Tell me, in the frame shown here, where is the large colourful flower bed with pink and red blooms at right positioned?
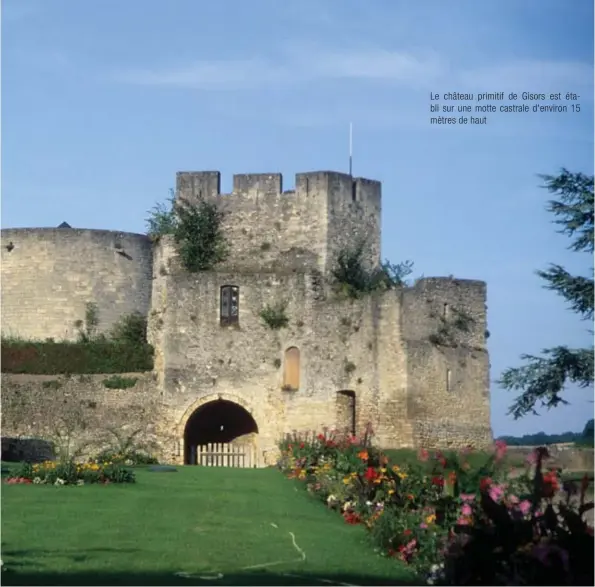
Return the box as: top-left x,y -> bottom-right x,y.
279,428 -> 594,585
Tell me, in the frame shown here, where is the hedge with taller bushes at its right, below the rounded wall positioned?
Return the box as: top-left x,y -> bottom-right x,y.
0,303 -> 153,375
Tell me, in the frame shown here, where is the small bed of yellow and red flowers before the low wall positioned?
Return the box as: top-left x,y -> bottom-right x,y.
6,461 -> 135,485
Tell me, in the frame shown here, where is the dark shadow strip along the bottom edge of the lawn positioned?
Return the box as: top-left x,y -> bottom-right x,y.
2,569 -> 423,586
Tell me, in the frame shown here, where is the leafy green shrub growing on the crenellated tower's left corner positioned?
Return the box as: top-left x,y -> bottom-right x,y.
147,191 -> 229,273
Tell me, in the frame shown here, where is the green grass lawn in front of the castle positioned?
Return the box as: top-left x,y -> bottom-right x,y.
2,467 -> 414,585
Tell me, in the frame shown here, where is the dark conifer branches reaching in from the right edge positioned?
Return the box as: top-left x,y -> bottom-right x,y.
498,169 -> 594,420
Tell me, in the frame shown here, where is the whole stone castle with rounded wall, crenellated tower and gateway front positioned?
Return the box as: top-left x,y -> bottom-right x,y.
1,172 -> 491,465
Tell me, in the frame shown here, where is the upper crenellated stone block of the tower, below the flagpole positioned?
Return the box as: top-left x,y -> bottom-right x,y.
176,171 -> 382,272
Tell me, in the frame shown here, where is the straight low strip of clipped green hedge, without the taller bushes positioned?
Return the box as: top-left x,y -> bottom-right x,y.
1,340 -> 153,375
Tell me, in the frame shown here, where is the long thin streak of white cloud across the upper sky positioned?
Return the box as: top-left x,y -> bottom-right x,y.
112,44 -> 593,107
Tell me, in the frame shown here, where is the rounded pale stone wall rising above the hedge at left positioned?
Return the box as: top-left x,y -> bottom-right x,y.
0,228 -> 153,340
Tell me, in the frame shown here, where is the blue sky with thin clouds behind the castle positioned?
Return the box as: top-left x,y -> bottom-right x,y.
2,0 -> 593,434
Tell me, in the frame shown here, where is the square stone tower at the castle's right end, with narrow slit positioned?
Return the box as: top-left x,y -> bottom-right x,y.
402,278 -> 492,448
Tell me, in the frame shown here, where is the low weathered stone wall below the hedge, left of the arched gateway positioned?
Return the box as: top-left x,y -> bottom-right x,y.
2,373 -> 177,460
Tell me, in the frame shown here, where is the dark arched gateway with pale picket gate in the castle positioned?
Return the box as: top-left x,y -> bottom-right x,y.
183,395 -> 258,467
